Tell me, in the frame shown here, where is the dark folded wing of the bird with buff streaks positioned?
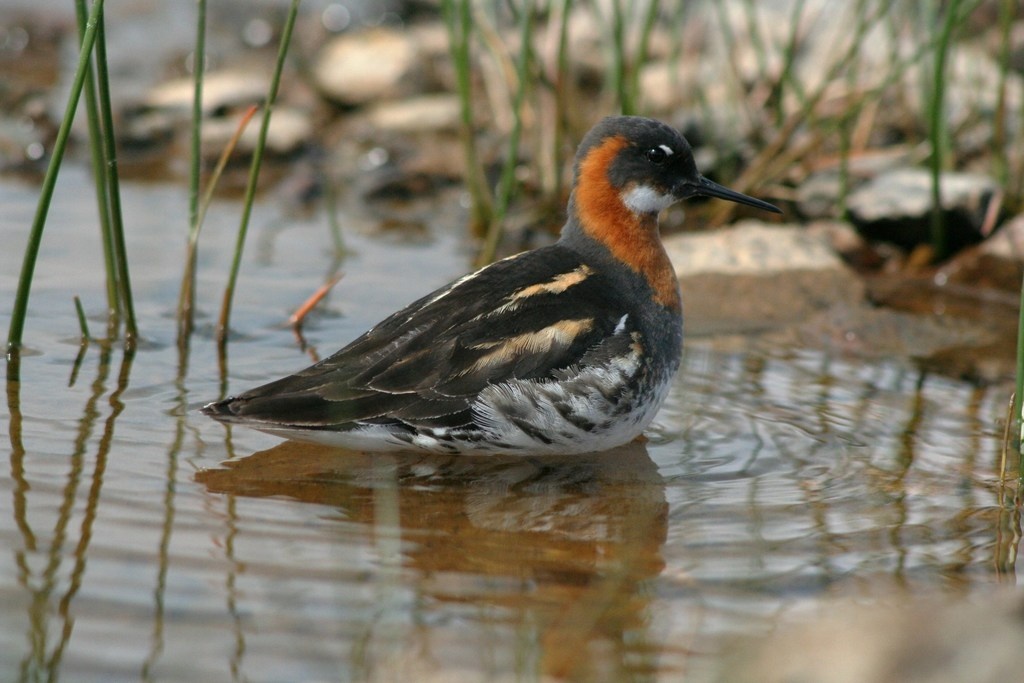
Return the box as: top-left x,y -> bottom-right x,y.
208,245 -> 628,429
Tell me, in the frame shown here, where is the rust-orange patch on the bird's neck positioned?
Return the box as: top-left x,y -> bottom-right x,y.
570,135 -> 681,310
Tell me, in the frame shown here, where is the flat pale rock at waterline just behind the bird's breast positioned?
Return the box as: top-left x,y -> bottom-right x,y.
665,220 -> 864,334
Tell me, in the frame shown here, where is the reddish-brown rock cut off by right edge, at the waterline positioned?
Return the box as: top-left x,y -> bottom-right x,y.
937,214 -> 1024,293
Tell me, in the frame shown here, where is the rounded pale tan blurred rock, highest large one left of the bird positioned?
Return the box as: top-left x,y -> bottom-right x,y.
312,29 -> 421,106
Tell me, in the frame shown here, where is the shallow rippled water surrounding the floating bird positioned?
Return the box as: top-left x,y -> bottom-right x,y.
0,166 -> 1020,681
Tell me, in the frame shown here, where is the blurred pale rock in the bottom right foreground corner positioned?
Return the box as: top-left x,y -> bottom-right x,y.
717,593 -> 1024,683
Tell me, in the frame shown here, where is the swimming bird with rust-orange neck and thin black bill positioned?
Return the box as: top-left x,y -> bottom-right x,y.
202,116 -> 781,456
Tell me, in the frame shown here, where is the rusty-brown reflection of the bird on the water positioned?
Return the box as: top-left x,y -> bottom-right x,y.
197,441 -> 668,679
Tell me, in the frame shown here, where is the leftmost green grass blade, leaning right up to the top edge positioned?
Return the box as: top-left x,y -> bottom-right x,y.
7,0 -> 103,362
